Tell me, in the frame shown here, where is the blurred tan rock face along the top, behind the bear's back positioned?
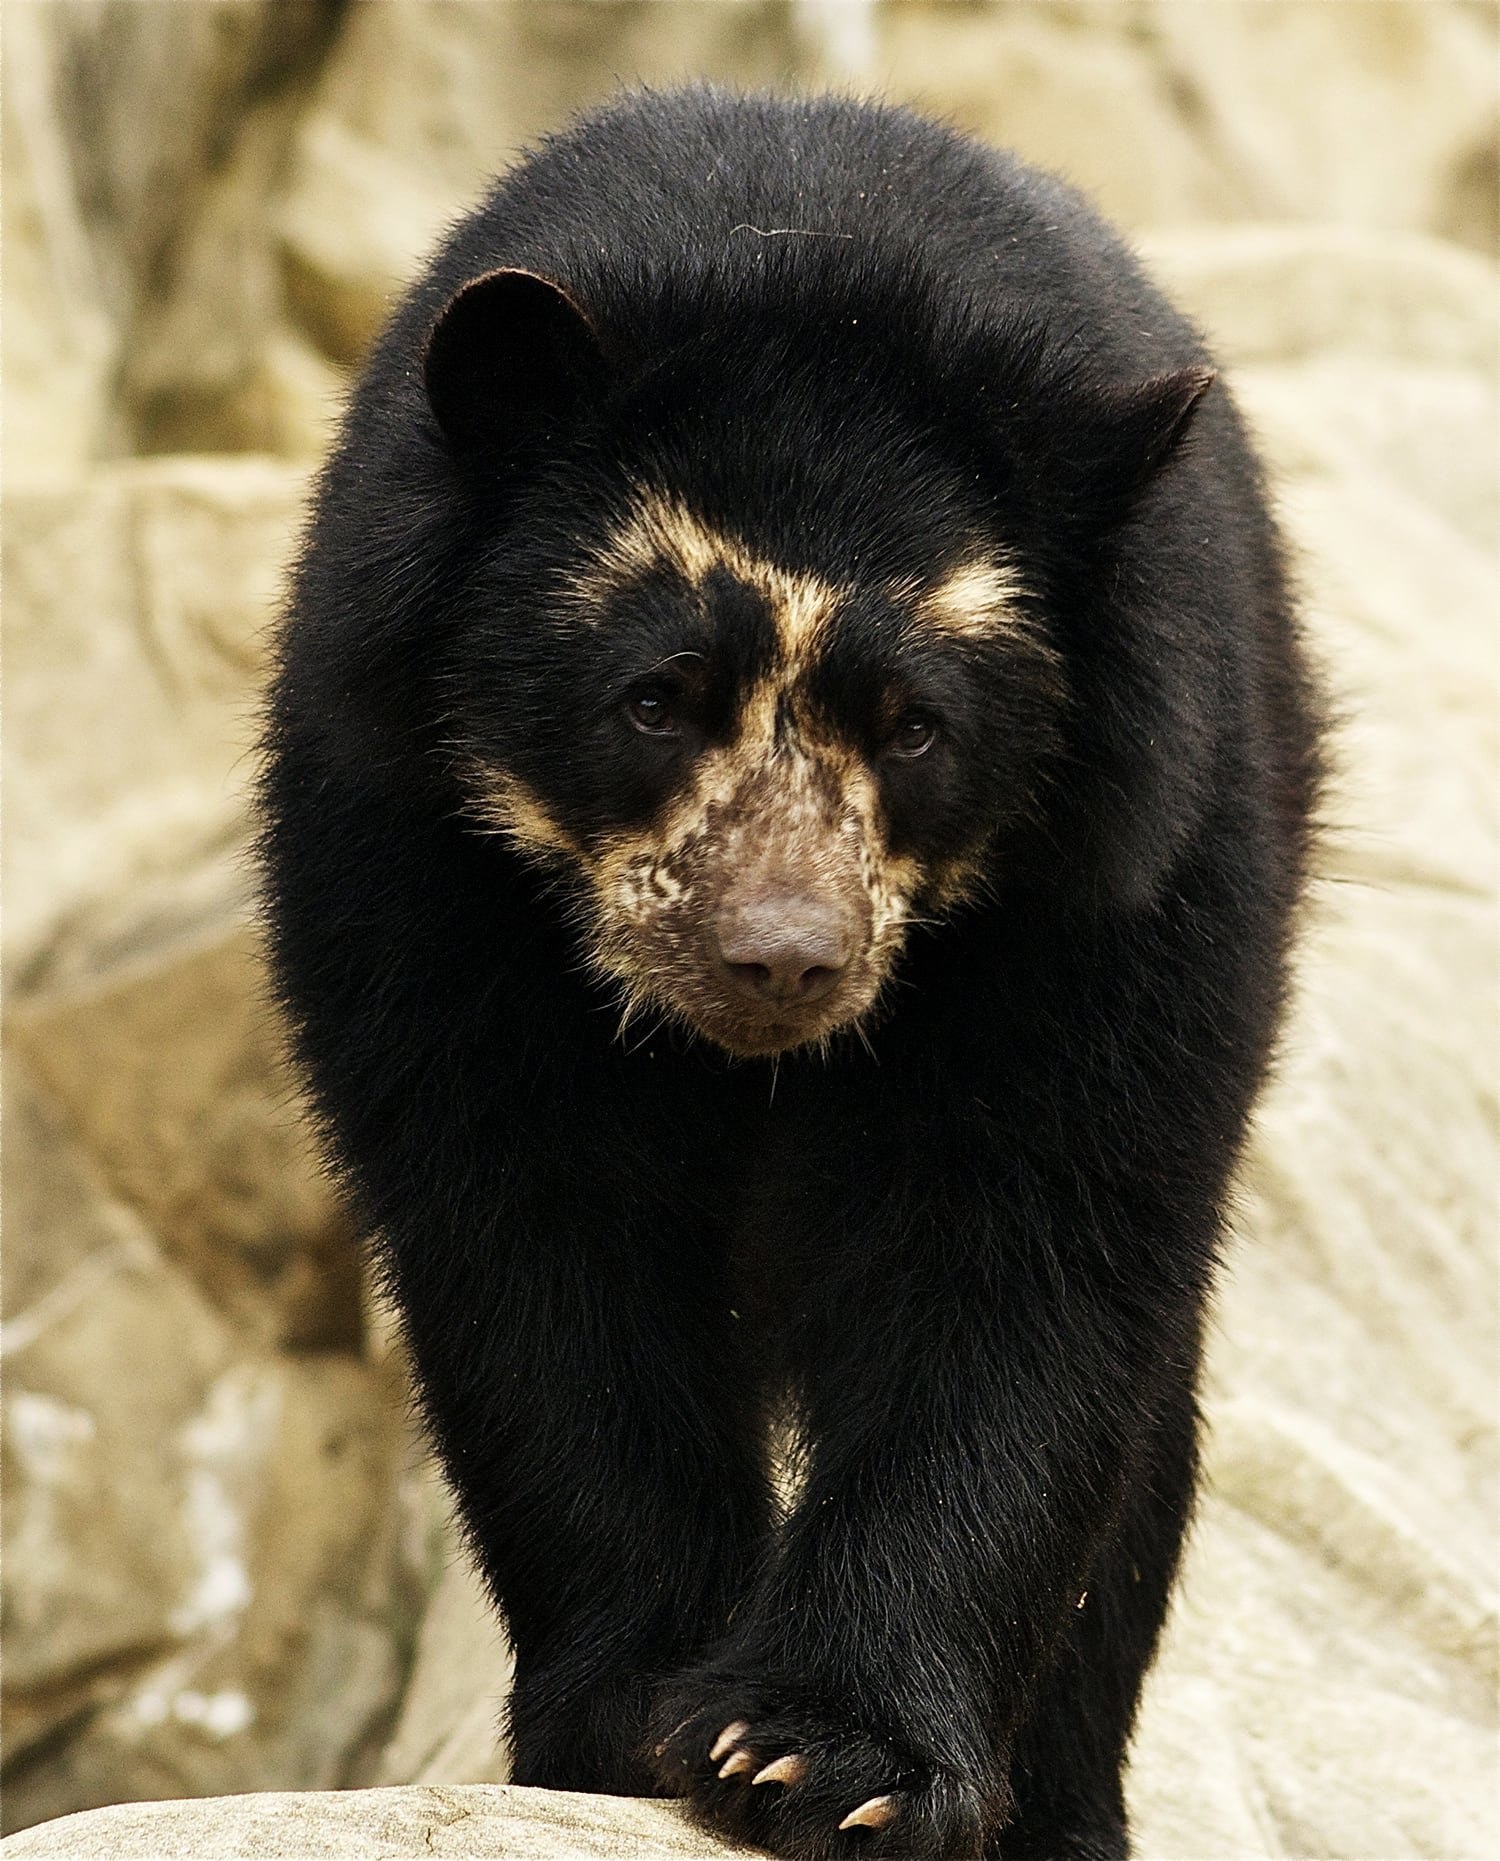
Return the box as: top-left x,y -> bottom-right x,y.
4,0 -> 1500,469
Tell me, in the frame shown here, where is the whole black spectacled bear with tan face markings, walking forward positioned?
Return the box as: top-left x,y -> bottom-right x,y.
261,89 -> 1318,1861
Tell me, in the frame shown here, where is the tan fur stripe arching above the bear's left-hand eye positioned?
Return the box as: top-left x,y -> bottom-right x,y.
577,491 -> 839,666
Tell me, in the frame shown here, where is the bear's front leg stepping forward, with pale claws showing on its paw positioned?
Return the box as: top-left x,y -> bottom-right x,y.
657,1146 -> 1197,1861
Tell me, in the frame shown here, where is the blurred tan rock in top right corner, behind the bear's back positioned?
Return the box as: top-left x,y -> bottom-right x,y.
874,0 -> 1500,253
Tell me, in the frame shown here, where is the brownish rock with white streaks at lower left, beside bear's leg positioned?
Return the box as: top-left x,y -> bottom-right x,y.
0,1053 -> 416,1828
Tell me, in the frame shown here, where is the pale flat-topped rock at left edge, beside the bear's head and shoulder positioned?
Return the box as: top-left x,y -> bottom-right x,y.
4,458 -> 305,990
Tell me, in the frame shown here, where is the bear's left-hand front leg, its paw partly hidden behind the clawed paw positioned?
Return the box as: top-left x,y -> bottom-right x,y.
372,1083 -> 770,1794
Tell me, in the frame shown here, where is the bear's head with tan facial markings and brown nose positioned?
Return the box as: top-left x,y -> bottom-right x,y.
424,270 -> 1206,1055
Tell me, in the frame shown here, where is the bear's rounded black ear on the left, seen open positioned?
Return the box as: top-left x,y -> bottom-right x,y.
422,270 -> 605,456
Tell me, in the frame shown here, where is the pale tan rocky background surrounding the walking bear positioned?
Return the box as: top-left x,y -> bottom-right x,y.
0,0 -> 1500,1855
